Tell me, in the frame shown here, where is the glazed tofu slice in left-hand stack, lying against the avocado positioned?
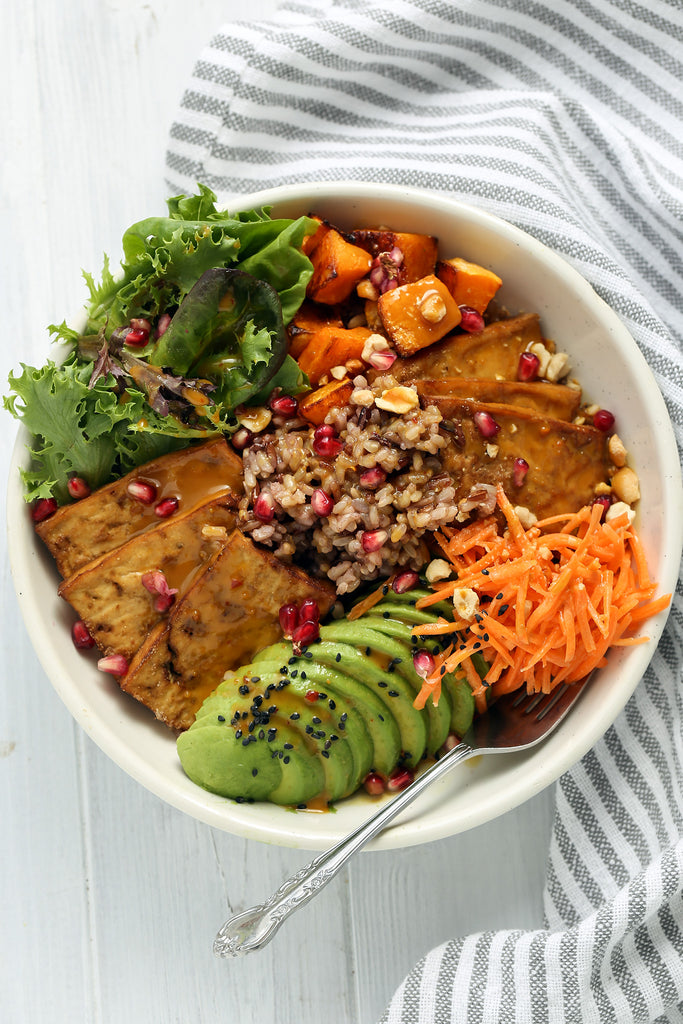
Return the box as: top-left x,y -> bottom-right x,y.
119,530 -> 335,729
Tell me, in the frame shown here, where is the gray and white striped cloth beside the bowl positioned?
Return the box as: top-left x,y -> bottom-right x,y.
167,0 -> 683,1024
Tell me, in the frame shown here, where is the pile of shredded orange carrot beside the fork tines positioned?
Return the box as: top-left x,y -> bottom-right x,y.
415,487 -> 671,711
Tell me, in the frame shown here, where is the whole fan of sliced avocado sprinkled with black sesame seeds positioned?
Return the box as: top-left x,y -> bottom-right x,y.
178,589 -> 485,807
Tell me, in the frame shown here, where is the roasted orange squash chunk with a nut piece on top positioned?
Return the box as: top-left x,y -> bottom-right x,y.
377,274 -> 461,356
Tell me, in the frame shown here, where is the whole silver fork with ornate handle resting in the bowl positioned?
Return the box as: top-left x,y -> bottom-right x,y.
213,683 -> 585,957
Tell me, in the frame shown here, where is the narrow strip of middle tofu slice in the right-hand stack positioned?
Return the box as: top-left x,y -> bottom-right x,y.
415,377 -> 581,420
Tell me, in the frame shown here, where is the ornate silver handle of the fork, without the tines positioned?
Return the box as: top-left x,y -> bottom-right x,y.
213,742 -> 474,957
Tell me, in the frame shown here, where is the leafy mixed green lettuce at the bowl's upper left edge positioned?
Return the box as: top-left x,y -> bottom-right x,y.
4,185 -> 317,504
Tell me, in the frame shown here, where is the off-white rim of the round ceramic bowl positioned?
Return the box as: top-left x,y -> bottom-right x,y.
7,181 -> 683,850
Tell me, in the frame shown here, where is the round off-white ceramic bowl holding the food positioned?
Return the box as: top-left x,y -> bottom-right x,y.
8,182 -> 683,850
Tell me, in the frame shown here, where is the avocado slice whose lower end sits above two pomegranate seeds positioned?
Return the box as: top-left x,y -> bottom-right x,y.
255,643 -> 401,777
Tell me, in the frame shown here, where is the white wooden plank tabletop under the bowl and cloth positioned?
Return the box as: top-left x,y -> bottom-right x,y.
0,0 -> 553,1024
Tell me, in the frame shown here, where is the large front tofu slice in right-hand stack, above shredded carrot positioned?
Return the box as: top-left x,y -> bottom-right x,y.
423,397 -> 610,518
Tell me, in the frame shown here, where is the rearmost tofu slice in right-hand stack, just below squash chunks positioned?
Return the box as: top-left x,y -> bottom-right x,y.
391,313 -> 543,381
